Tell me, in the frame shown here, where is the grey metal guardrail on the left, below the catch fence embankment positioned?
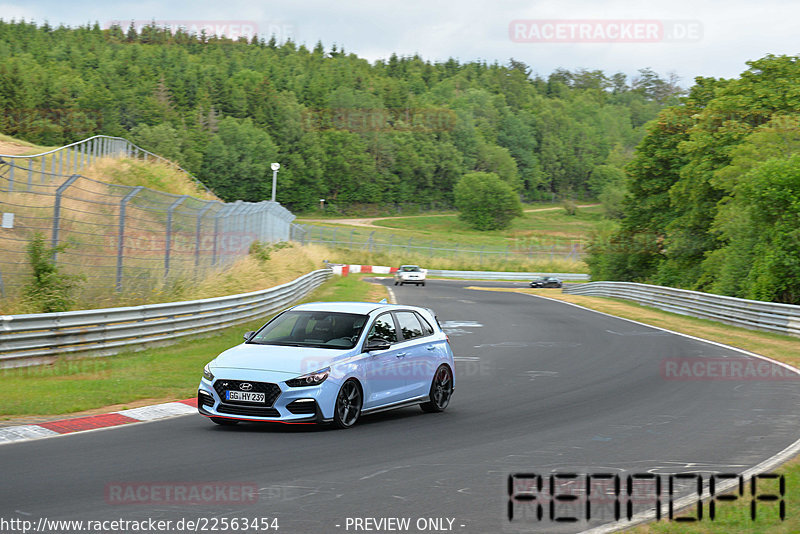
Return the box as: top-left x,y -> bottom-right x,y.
0,269 -> 331,368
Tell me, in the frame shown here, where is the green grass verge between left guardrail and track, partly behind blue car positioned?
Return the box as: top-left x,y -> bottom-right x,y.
0,276 -> 385,419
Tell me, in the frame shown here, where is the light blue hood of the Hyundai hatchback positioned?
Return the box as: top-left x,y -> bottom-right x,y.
210,343 -> 354,376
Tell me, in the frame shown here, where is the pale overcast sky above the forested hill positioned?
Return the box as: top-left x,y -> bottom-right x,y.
0,0 -> 800,86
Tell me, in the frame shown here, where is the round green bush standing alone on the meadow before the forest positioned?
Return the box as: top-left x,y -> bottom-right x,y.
453,172 -> 522,230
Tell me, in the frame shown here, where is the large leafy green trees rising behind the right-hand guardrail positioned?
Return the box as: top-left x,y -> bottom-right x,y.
589,55 -> 800,304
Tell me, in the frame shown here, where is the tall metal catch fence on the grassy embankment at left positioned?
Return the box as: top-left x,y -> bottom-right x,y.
0,136 -> 294,297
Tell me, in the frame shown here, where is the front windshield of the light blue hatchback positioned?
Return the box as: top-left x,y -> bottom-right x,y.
247,311 -> 368,349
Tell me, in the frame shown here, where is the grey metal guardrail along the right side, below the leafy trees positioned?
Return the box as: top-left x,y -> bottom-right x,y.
563,282 -> 800,336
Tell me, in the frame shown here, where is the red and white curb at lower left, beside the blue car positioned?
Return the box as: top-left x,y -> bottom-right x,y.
0,398 -> 197,445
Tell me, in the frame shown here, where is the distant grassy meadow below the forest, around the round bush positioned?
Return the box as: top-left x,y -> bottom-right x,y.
298,205 -> 612,273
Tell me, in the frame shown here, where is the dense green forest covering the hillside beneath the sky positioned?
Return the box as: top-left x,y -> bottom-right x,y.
0,21 -> 682,213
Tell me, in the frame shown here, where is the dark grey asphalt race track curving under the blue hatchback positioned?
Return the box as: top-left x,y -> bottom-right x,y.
0,280 -> 800,534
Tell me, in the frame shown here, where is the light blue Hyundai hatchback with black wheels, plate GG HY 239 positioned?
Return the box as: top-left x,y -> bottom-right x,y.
197,302 -> 455,428
